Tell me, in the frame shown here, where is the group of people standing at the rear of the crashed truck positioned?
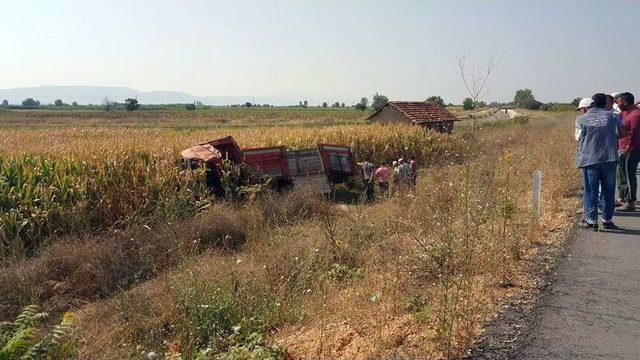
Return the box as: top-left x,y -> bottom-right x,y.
358,158 -> 418,202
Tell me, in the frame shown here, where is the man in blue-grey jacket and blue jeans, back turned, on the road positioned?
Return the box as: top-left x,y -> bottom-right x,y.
576,93 -> 618,230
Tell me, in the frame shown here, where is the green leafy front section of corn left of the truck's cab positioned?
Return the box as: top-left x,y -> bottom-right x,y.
0,151 -> 205,260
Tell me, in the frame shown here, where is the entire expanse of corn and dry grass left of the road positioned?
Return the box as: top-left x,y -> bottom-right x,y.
0,108 -> 579,359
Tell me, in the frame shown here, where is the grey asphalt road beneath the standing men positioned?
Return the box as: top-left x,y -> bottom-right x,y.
512,173 -> 640,359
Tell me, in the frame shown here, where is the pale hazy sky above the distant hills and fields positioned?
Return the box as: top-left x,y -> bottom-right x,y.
0,0 -> 640,103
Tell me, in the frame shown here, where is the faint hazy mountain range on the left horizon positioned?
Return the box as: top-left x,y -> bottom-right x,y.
0,86 -> 278,105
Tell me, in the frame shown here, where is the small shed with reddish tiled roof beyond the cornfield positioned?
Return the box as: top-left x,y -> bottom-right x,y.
369,101 -> 458,133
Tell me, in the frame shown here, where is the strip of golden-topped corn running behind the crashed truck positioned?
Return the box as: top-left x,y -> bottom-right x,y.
0,125 -> 467,164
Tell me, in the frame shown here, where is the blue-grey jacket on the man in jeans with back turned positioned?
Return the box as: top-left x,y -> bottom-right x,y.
576,108 -> 618,168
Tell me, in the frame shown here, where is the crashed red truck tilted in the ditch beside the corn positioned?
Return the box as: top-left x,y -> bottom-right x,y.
180,136 -> 357,194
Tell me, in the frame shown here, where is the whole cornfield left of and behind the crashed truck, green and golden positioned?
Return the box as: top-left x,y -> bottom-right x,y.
0,125 -> 465,260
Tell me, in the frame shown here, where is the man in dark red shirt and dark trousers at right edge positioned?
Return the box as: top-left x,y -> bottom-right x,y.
617,92 -> 640,211
